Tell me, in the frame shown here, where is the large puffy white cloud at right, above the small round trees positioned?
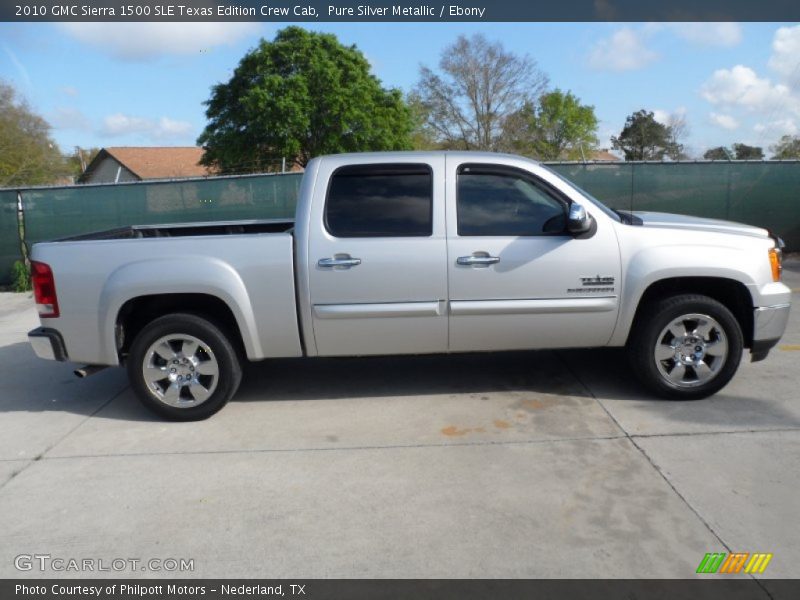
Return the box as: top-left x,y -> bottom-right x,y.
700,65 -> 800,112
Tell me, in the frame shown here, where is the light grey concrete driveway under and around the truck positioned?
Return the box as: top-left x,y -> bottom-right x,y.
0,262 -> 800,597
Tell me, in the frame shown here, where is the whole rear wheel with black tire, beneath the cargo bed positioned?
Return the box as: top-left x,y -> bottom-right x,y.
127,313 -> 242,421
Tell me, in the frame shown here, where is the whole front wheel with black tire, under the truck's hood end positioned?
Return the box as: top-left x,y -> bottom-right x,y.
628,294 -> 744,400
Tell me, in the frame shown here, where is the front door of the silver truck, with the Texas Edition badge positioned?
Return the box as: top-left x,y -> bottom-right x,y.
447,154 -> 621,351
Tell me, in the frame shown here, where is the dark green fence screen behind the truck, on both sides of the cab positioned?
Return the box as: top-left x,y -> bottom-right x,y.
0,161 -> 800,284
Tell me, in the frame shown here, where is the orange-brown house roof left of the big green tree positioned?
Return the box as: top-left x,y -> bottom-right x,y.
84,146 -> 213,179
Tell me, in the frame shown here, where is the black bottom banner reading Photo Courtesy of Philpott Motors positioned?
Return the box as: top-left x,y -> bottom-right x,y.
0,576 -> 800,600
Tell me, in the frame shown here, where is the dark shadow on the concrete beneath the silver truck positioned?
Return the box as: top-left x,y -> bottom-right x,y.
0,343 -> 800,427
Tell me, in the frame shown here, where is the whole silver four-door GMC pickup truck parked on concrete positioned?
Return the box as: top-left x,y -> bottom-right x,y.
29,152 -> 791,420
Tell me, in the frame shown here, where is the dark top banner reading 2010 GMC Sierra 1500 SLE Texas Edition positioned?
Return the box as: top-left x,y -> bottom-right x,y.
0,0 -> 800,22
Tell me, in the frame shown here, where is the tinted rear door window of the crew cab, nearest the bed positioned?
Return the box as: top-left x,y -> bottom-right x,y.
325,164 -> 433,237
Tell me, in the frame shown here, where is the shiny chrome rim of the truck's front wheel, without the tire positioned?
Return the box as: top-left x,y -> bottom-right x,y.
654,313 -> 728,388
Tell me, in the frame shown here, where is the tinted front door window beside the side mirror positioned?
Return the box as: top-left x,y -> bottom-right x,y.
456,165 -> 567,237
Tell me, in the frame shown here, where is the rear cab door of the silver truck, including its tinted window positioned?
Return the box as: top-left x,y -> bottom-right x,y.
308,155 -> 447,356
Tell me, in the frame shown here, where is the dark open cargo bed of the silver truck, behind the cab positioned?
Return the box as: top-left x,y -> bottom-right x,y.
55,219 -> 294,242
